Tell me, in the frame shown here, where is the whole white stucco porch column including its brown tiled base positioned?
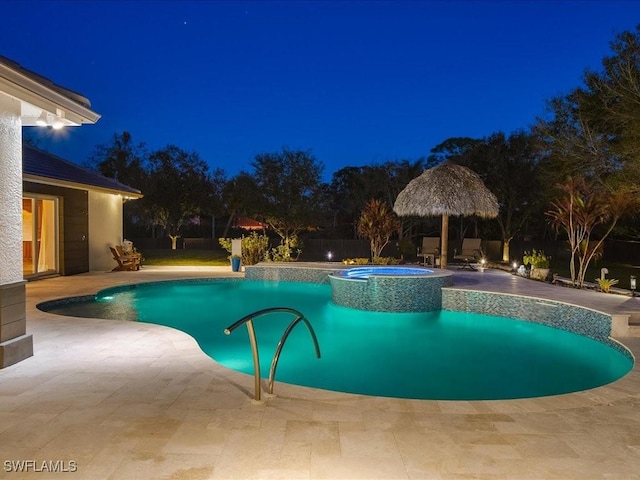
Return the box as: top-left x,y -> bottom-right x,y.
0,92 -> 33,368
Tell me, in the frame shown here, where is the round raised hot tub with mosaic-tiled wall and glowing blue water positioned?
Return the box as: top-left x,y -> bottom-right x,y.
329,266 -> 453,312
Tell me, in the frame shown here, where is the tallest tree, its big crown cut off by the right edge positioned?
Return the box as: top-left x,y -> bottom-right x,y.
535,26 -> 640,195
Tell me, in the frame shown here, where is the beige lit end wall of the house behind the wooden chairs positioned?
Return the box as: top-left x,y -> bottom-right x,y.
89,191 -> 123,272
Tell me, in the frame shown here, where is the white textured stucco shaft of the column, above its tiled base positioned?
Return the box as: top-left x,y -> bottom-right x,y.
0,93 -> 23,285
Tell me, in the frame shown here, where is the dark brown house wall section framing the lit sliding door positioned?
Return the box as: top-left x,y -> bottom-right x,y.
20,182 -> 89,275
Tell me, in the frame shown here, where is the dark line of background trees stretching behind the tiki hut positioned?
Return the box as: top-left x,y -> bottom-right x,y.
80,26 -> 640,260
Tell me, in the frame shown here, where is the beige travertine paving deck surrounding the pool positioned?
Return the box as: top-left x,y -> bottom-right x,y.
0,267 -> 640,480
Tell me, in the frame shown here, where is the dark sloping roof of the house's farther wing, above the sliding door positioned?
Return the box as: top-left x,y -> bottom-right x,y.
22,145 -> 142,198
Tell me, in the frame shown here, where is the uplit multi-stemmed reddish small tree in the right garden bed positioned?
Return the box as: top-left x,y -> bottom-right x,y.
546,177 -> 638,287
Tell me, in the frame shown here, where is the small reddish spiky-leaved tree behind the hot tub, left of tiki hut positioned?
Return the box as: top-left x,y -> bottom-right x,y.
358,198 -> 400,262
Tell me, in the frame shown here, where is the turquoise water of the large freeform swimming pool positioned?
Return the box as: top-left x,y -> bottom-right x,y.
42,279 -> 632,400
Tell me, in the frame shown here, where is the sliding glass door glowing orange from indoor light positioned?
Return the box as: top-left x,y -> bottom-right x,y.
22,196 -> 58,276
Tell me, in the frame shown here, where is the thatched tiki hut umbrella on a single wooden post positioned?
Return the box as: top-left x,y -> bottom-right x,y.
393,162 -> 498,268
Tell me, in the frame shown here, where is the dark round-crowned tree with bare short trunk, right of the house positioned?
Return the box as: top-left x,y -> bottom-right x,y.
143,145 -> 213,250
